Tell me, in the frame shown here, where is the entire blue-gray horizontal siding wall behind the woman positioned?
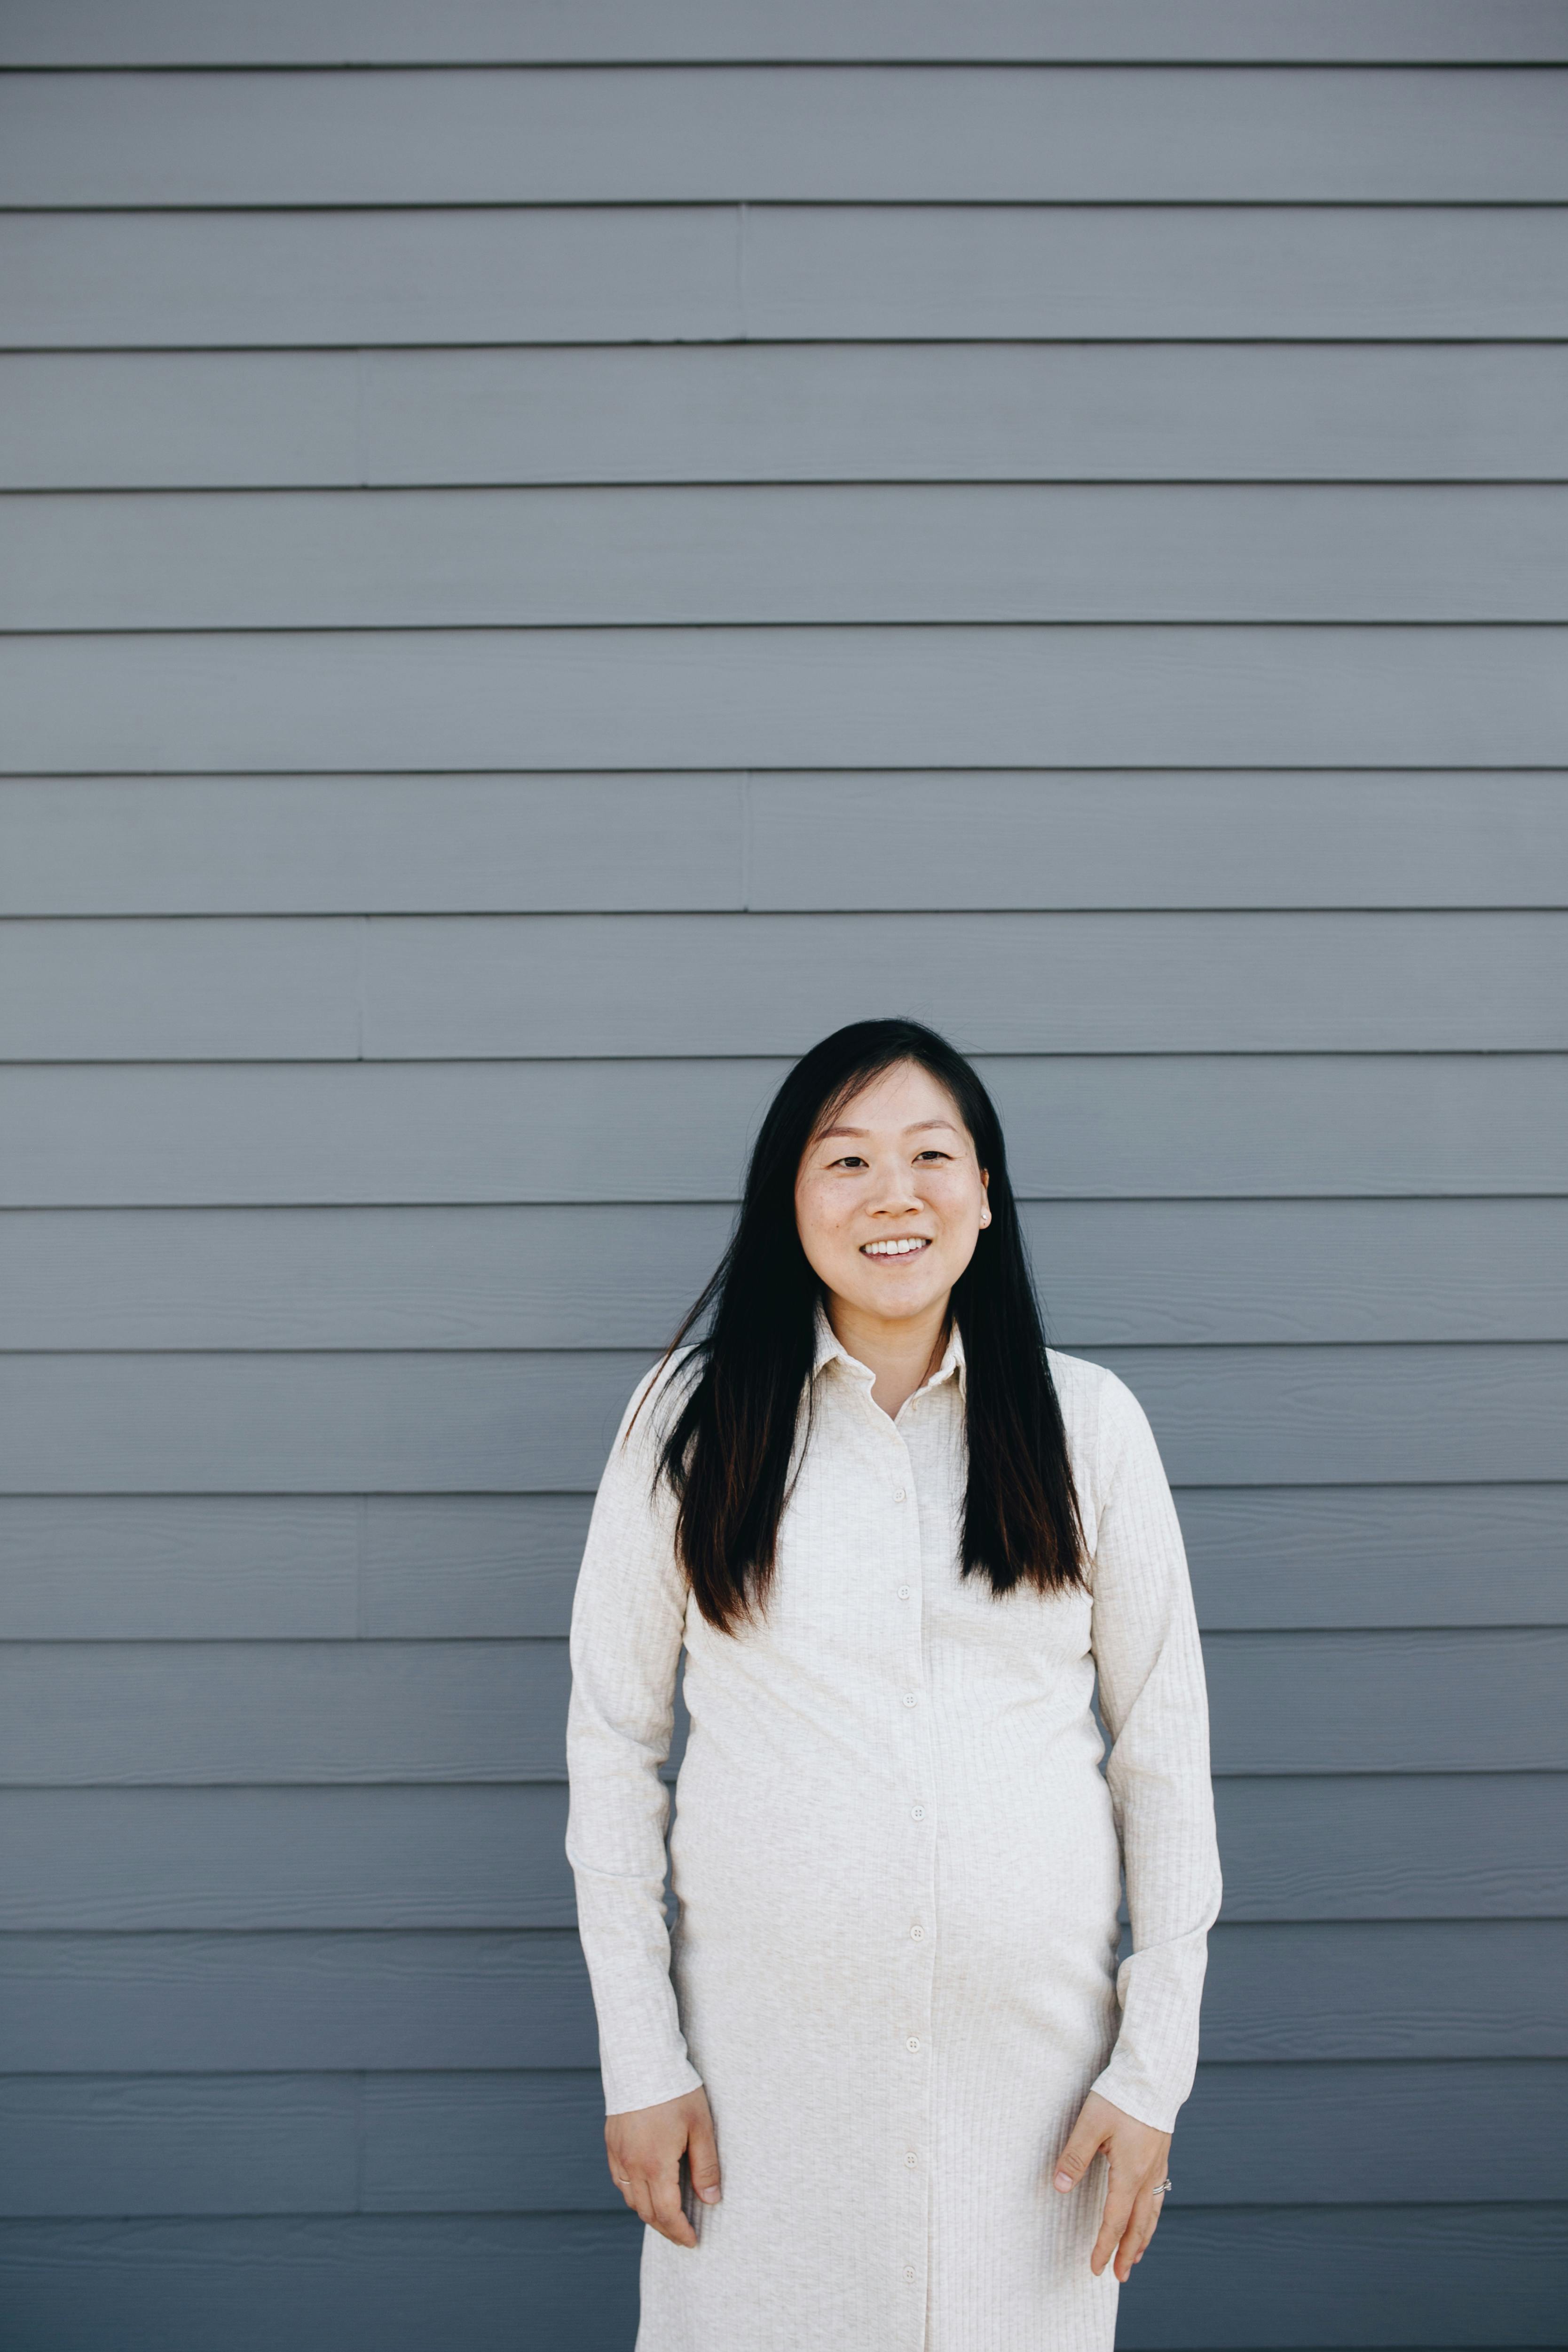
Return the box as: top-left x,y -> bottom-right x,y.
0,0 -> 1568,2352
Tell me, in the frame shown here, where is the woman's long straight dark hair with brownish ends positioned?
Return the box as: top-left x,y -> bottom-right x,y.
656,1021 -> 1086,1632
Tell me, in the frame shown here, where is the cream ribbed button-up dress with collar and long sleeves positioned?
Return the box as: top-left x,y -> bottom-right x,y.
567,1310 -> 1220,2352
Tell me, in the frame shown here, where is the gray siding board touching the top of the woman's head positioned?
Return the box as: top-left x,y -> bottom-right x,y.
0,917 -> 1568,1061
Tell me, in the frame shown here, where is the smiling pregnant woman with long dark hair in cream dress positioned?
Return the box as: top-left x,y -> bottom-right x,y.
567,1021 -> 1220,2352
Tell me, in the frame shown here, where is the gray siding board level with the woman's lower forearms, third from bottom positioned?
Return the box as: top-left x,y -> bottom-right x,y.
0,1919 -> 1568,2069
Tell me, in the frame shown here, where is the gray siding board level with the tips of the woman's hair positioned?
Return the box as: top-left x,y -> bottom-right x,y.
0,1482 -> 1568,1642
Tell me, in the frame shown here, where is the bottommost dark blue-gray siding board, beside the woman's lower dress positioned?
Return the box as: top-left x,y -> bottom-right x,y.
0,2204 -> 1568,2352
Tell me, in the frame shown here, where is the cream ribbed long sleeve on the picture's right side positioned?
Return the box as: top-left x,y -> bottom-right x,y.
1093,1373 -> 1220,2131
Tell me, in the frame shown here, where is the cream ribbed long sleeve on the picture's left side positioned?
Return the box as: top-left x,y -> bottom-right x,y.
567,1381 -> 701,2115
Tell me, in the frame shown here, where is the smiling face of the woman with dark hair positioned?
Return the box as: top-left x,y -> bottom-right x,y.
795,1061 -> 990,1322
